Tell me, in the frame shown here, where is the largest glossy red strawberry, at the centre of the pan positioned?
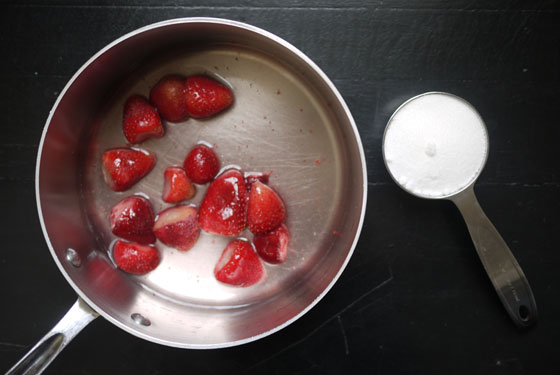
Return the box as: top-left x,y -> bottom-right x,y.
198,170 -> 247,236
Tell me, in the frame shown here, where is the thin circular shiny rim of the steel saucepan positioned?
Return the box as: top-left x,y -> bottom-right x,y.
35,17 -> 368,349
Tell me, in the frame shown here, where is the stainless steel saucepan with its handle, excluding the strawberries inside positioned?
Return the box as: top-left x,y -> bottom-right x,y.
9,18 -> 367,374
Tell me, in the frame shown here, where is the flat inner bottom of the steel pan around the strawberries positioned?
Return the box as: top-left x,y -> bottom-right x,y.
83,47 -> 343,308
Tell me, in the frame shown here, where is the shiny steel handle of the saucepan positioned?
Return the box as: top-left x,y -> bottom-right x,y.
6,298 -> 99,375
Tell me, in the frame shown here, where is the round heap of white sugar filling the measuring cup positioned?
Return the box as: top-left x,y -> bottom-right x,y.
383,93 -> 488,198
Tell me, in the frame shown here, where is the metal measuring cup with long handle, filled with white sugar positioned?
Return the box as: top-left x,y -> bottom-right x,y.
383,92 -> 537,327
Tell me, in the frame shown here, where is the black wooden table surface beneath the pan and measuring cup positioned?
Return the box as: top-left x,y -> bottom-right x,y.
0,0 -> 560,374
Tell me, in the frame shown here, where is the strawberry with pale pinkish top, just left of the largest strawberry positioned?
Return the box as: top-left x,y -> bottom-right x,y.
154,205 -> 200,251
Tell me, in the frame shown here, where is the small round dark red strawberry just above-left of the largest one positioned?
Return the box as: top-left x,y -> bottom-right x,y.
183,145 -> 220,184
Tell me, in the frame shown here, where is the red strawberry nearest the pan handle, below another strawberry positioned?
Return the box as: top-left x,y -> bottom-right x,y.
113,240 -> 160,275
